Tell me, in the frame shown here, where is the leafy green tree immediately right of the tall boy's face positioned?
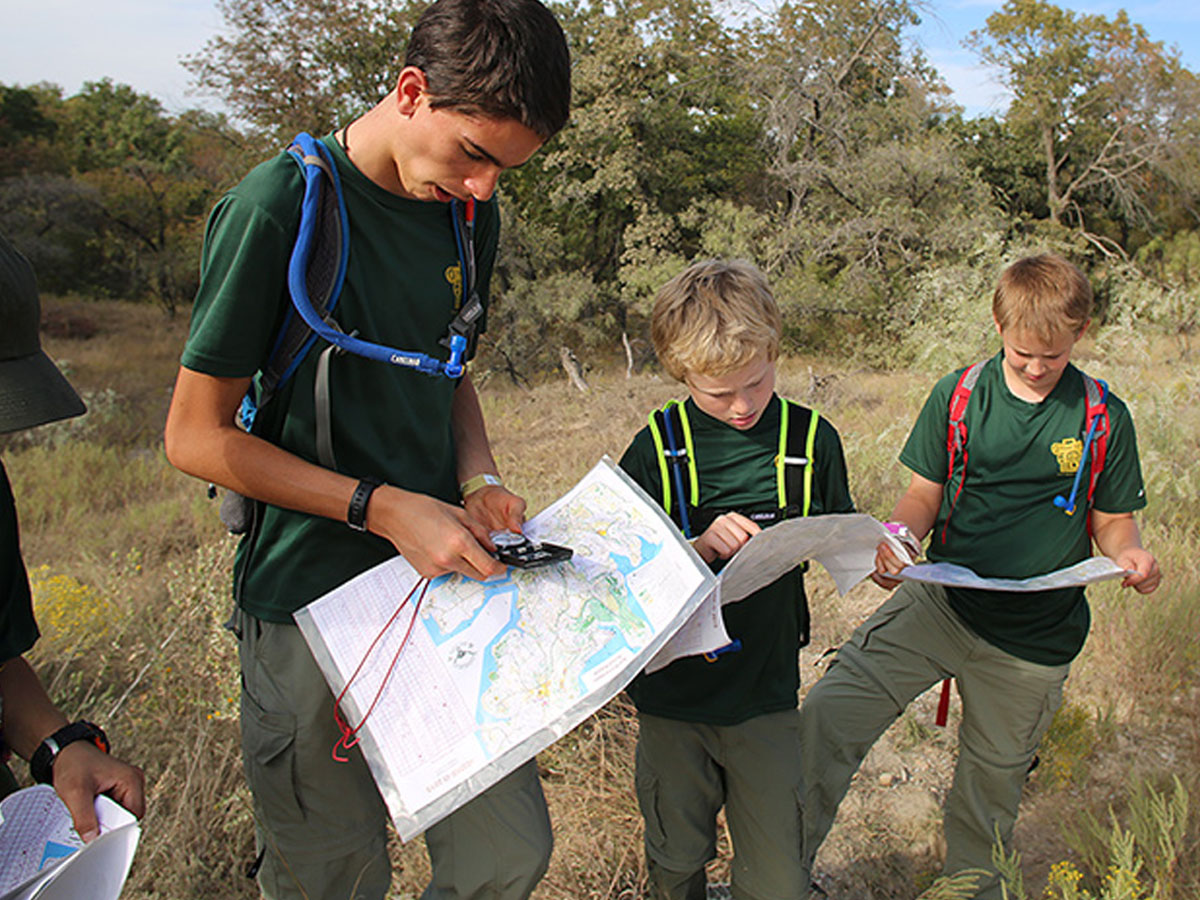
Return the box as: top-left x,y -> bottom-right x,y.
487,0 -> 766,365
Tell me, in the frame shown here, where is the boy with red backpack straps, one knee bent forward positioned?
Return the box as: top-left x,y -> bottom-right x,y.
800,254 -> 1160,900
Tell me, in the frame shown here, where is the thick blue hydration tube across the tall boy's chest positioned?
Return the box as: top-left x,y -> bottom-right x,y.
288,140 -> 467,378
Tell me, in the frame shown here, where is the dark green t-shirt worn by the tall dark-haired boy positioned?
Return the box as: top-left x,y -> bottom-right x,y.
182,137 -> 499,622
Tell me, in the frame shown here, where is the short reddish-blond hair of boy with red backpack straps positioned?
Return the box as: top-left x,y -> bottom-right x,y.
991,253 -> 1092,342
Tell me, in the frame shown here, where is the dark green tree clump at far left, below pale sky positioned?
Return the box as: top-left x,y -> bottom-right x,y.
0,79 -> 244,311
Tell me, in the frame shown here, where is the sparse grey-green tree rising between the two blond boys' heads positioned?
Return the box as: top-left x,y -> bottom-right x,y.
729,0 -> 997,349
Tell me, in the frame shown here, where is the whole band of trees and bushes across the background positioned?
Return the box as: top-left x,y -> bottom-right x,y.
0,0 -> 1200,367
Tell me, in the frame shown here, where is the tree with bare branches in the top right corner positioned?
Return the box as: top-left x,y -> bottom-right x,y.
970,0 -> 1196,252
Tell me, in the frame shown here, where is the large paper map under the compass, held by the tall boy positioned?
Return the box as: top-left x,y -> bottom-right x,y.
295,460 -> 715,840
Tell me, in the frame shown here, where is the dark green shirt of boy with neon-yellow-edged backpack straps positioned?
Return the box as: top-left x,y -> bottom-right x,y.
620,396 -> 854,725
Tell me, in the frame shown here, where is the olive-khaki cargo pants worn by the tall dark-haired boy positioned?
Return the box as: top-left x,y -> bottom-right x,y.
229,611 -> 552,900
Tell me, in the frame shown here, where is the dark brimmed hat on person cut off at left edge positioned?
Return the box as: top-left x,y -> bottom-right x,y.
0,234 -> 88,432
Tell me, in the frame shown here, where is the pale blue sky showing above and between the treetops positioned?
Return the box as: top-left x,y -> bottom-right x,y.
0,0 -> 1200,115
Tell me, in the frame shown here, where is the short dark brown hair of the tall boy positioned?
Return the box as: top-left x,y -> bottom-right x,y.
404,0 -> 571,139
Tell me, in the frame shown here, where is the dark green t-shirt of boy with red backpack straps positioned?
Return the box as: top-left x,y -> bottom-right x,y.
900,354 -> 1146,666
